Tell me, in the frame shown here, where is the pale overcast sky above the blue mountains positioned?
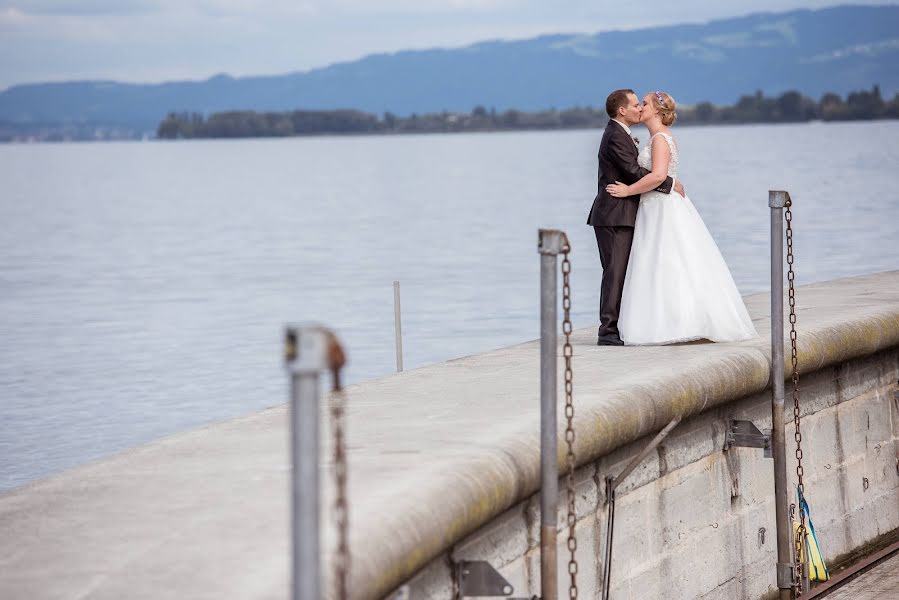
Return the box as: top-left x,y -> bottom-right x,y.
0,0 -> 899,89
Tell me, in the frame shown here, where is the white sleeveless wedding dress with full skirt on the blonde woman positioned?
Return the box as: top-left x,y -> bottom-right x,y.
618,133 -> 757,346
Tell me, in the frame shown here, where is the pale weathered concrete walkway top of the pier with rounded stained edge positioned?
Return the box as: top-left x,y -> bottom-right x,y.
0,271 -> 899,600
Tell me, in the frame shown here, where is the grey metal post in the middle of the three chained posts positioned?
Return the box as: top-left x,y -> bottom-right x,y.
538,229 -> 566,600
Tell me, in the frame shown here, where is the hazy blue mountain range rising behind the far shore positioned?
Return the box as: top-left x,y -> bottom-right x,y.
0,6 -> 899,131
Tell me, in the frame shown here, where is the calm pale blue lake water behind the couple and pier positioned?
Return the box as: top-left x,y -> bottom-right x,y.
0,121 -> 899,490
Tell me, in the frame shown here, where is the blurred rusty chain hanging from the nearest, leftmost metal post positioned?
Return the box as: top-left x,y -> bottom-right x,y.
330,339 -> 350,600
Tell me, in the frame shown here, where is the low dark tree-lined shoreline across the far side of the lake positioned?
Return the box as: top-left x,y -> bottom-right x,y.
0,85 -> 899,143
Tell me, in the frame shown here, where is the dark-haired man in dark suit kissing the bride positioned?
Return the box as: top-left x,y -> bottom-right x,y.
587,89 -> 683,346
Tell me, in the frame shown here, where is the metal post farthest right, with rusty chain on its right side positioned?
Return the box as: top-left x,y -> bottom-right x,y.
768,191 -> 793,600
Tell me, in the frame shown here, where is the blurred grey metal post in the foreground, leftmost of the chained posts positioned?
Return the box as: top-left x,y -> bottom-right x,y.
285,326 -> 328,600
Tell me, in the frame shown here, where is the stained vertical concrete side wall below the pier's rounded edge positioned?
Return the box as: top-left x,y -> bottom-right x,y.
394,348 -> 899,600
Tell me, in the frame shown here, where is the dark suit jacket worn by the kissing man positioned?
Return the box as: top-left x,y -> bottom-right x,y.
587,120 -> 674,227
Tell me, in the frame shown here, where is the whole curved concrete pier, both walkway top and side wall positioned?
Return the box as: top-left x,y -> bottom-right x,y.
0,271 -> 899,600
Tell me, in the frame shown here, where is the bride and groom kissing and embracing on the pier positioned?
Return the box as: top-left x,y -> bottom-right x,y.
587,89 -> 757,346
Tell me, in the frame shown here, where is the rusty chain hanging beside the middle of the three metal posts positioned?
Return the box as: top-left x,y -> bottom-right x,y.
562,244 -> 578,600
